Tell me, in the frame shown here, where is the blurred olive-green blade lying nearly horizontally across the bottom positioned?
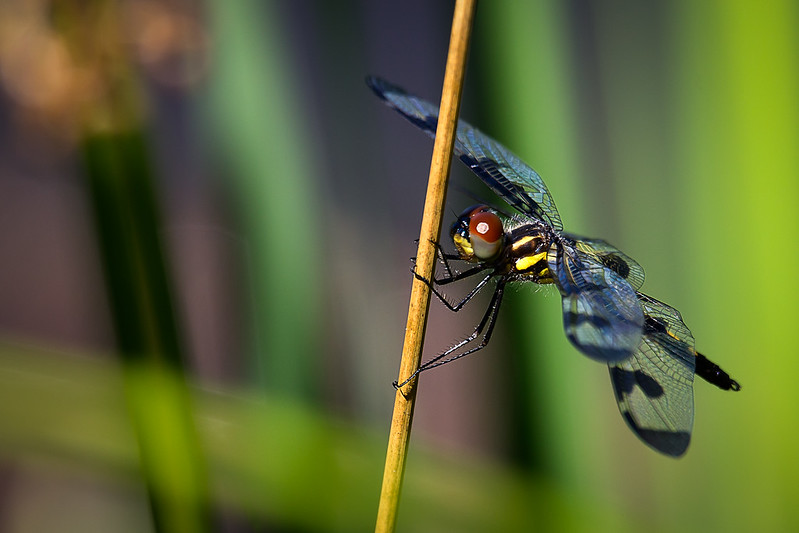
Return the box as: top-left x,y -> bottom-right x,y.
0,345 -> 640,533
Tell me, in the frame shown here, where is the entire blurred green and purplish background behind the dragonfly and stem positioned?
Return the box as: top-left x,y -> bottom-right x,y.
0,0 -> 799,532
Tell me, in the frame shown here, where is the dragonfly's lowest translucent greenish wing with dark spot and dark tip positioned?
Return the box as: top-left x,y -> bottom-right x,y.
608,293 -> 696,457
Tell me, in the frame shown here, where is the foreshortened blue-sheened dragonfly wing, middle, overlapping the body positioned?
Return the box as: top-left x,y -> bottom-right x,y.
547,239 -> 644,363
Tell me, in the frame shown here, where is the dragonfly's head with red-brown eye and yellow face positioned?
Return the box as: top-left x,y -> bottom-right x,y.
450,205 -> 505,263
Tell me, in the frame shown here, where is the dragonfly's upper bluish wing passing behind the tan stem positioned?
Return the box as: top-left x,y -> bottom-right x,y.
366,77 -> 563,231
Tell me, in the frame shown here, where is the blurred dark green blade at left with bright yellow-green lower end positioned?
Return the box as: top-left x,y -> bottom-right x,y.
83,130 -> 210,531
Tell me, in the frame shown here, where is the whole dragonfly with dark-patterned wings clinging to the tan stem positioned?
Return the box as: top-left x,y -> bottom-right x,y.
366,77 -> 741,457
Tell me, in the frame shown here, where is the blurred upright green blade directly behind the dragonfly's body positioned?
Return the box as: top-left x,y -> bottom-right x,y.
475,1 -> 592,483
